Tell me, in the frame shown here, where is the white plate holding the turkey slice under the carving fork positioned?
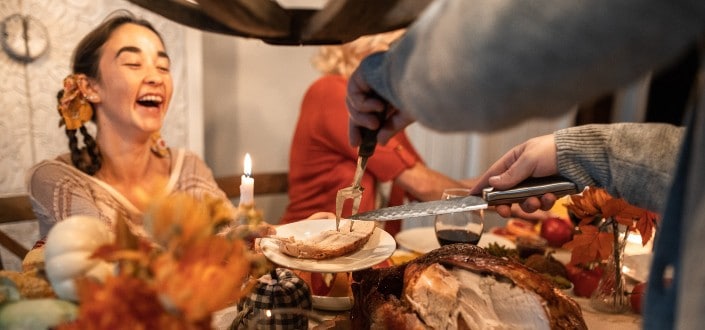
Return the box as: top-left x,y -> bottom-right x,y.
260,219 -> 397,273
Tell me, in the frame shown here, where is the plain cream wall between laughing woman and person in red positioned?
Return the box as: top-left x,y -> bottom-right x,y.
203,33 -> 318,223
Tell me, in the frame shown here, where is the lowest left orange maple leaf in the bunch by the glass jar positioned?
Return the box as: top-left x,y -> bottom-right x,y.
563,225 -> 614,265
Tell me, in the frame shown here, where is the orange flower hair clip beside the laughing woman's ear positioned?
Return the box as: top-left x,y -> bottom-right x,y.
59,73 -> 93,130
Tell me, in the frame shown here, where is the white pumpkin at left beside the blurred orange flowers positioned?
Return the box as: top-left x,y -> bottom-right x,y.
44,216 -> 115,301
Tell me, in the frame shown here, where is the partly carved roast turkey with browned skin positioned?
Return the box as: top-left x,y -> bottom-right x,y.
351,244 -> 587,329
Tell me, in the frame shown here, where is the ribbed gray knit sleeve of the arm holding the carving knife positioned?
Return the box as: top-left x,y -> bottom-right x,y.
555,123 -> 684,211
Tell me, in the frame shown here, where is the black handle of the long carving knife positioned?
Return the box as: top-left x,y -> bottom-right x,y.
482,176 -> 579,205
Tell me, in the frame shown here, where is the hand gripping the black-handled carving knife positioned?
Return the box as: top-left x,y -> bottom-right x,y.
472,134 -> 558,217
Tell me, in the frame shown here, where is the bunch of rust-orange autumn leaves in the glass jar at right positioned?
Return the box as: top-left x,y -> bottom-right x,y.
563,187 -> 657,265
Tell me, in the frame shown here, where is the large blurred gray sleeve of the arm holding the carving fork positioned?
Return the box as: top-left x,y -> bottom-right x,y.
360,0 -> 705,131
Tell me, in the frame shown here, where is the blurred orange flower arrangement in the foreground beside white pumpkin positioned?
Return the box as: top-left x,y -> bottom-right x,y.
59,194 -> 253,329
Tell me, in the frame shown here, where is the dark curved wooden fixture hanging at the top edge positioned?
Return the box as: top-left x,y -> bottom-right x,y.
129,0 -> 433,45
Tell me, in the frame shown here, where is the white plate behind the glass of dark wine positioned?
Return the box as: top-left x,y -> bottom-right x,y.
395,227 -> 515,253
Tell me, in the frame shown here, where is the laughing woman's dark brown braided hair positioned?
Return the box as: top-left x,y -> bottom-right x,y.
57,10 -> 164,175
